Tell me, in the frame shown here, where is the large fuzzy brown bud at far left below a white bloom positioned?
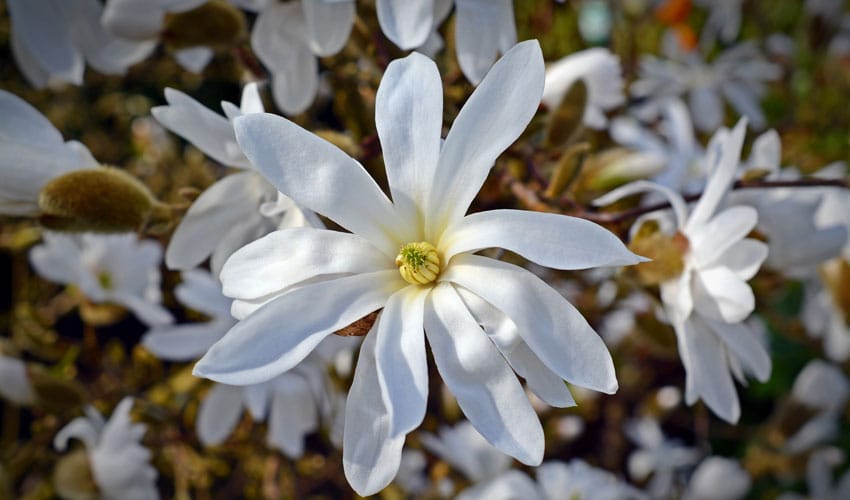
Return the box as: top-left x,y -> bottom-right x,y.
38,167 -> 163,233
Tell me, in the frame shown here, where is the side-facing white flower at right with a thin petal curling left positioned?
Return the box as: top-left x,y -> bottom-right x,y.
596,119 -> 771,423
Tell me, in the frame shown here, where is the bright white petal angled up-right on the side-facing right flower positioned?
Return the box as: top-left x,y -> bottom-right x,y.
687,206 -> 758,266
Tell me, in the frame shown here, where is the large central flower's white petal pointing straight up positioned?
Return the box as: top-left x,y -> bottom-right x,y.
375,52 -> 443,225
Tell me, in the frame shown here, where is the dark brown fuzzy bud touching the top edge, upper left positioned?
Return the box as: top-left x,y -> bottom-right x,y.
162,0 -> 245,50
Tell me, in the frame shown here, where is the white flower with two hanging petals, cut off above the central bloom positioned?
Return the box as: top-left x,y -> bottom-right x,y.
377,0 -> 516,85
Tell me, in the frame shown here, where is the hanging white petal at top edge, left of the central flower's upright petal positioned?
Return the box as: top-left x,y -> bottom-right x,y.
301,0 -> 354,57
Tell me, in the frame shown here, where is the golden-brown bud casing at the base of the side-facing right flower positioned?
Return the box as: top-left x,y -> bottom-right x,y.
629,221 -> 688,285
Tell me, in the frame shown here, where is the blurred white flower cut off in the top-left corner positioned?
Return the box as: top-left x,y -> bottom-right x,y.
6,0 -> 154,88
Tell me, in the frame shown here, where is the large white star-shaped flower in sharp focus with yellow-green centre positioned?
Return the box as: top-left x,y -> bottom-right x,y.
195,41 -> 640,495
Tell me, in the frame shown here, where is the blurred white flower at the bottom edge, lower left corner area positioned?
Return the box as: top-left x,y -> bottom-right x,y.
53,397 -> 159,500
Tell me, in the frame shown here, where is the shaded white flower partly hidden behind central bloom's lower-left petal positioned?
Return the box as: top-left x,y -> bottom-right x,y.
142,269 -> 350,458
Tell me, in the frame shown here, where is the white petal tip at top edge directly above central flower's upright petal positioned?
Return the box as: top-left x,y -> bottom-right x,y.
375,0 -> 434,50
